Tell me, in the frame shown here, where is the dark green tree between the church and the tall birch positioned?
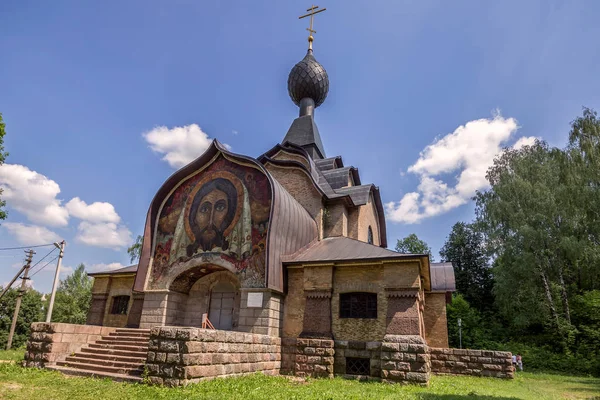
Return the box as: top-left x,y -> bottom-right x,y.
440,222 -> 494,311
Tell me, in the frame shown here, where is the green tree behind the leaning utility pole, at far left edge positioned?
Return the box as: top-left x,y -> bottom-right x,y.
0,288 -> 44,349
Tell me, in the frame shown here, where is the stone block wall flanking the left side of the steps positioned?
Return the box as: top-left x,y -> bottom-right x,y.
23,322 -> 116,367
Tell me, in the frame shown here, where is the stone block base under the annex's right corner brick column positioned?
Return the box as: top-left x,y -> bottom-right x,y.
381,335 -> 431,385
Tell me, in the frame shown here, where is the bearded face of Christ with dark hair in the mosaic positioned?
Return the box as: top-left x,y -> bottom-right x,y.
187,178 -> 237,256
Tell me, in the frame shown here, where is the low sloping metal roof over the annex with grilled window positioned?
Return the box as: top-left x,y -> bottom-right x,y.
282,236 -> 424,263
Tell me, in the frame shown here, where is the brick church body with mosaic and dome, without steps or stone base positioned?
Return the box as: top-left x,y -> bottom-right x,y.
88,34 -> 454,347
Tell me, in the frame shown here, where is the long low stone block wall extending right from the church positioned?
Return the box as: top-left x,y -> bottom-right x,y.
430,348 -> 515,379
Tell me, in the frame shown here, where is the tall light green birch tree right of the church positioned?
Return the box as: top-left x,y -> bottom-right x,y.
476,142 -> 579,347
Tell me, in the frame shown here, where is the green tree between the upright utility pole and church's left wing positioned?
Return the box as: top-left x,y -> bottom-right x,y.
52,264 -> 92,324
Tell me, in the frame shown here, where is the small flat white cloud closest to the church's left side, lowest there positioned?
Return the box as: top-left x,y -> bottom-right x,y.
76,221 -> 132,249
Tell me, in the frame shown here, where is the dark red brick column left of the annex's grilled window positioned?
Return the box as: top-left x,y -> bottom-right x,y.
300,289 -> 333,339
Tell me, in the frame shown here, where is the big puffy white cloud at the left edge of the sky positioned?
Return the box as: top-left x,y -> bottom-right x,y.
0,164 -> 69,226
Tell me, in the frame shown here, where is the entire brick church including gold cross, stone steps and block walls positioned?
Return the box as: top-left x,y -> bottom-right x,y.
26,8 -> 511,385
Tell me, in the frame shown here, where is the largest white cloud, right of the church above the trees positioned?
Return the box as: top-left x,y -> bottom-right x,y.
385,113 -> 536,224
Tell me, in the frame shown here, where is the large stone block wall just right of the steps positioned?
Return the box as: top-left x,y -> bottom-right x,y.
146,327 -> 281,386
